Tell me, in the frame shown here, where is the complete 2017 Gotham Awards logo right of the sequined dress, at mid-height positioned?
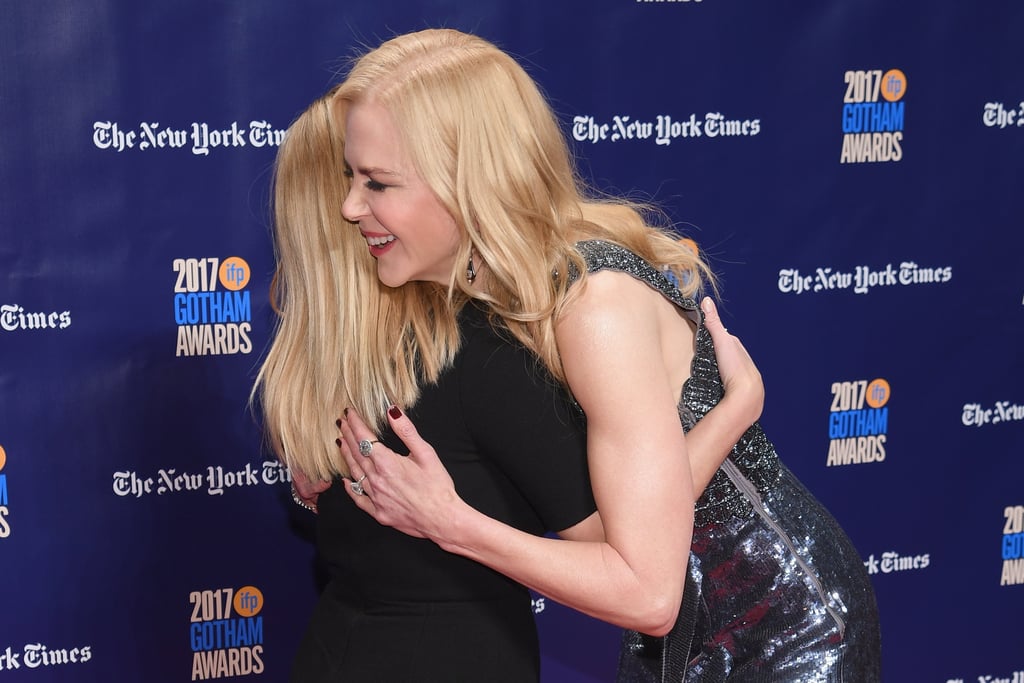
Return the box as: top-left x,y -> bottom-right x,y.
825,378 -> 891,467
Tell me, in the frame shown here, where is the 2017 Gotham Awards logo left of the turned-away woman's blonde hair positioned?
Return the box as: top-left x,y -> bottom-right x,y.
173,256 -> 253,356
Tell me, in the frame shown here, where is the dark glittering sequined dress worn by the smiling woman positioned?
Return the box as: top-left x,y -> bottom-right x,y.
577,241 -> 881,683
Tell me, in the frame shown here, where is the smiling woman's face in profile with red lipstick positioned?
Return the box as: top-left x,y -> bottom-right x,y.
342,101 -> 459,287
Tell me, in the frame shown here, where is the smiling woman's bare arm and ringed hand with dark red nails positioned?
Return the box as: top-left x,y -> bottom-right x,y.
342,279 -> 716,634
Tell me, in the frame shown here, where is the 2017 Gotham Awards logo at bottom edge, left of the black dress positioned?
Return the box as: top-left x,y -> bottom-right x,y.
188,586 -> 264,681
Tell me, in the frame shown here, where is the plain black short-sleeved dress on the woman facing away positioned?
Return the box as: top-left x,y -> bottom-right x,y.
291,304 -> 596,683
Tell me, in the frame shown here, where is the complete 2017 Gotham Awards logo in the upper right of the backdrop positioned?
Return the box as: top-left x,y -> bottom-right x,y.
840,69 -> 906,164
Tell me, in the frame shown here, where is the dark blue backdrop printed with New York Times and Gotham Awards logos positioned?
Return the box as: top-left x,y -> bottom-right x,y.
0,0 -> 1024,683
